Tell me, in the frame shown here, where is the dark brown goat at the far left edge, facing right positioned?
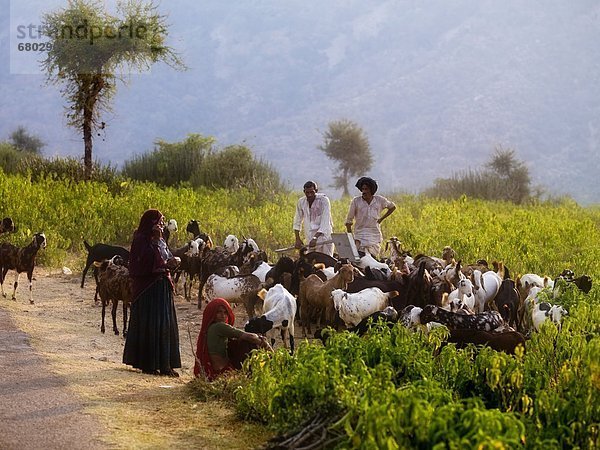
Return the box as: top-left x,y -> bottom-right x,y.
0,233 -> 46,303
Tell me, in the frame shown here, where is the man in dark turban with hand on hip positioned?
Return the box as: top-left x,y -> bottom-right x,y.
346,177 -> 396,257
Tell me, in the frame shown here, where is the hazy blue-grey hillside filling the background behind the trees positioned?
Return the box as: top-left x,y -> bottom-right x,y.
0,0 -> 600,203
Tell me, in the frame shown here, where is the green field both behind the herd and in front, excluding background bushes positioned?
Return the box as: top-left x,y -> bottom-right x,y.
0,174 -> 600,448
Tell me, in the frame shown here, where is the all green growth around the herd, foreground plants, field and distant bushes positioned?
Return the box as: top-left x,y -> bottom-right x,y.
0,125 -> 600,449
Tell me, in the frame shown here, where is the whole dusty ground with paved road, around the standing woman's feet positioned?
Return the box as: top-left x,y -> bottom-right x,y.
0,267 -> 269,450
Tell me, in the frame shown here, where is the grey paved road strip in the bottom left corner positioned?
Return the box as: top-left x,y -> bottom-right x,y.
0,308 -> 107,449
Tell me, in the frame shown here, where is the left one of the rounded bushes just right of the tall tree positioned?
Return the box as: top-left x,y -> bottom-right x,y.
123,134 -> 215,186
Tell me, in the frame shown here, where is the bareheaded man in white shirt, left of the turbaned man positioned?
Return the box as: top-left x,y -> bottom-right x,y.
294,181 -> 333,256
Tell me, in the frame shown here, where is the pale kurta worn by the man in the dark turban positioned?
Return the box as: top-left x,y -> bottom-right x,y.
346,195 -> 396,250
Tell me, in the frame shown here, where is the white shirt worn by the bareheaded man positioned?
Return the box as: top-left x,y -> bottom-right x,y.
293,193 -> 333,255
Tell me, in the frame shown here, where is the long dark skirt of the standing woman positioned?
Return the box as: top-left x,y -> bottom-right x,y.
123,277 -> 181,373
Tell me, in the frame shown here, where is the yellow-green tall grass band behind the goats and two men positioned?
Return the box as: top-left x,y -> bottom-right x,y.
0,174 -> 600,282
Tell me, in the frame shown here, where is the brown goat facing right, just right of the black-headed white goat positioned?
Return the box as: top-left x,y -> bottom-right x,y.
298,264 -> 354,337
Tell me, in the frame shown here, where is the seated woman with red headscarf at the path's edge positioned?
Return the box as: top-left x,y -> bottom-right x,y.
194,298 -> 271,381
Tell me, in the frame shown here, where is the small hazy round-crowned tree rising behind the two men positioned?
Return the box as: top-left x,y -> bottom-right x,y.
318,120 -> 373,197
